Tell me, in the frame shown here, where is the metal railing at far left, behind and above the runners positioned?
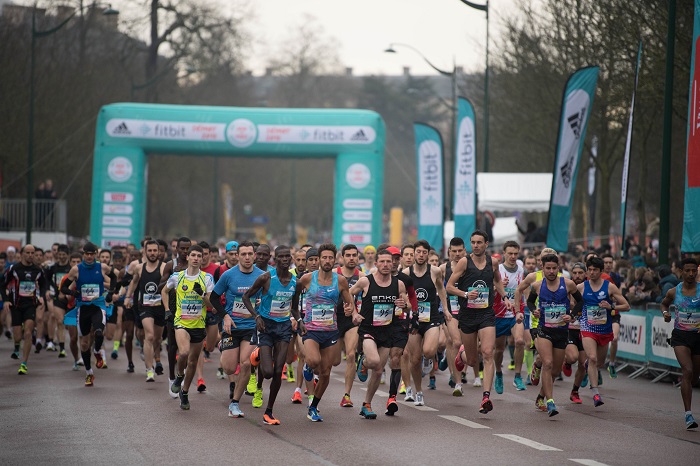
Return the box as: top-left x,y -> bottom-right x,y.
0,199 -> 66,232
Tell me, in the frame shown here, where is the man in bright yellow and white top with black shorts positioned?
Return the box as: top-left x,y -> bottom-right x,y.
161,246 -> 214,410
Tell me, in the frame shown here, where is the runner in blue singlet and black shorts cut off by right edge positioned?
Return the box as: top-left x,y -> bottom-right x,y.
661,258 -> 700,430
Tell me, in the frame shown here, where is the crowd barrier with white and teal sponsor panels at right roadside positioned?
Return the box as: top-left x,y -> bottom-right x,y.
617,305 -> 680,383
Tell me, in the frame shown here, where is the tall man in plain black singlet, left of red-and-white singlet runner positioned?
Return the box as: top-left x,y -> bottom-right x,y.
447,230 -> 513,414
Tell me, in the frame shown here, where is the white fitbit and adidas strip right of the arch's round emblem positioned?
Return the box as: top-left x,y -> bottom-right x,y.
257,125 -> 377,144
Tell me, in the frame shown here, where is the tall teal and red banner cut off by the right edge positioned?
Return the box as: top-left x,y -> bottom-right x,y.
681,0 -> 700,252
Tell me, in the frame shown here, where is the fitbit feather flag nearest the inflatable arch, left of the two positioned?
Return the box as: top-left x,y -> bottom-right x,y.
413,123 -> 445,251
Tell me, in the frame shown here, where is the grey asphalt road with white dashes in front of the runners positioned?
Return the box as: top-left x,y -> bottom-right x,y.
0,337 -> 700,465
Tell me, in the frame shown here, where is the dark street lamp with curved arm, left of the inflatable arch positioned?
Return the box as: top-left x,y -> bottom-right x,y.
25,3 -> 119,244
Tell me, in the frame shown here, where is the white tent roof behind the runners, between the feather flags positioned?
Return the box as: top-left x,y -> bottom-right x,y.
476,172 -> 552,212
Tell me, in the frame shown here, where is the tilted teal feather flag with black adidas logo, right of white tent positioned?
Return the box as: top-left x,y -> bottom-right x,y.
547,66 -> 599,251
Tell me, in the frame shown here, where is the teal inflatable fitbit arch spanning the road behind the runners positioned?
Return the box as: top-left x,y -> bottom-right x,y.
90,103 -> 385,247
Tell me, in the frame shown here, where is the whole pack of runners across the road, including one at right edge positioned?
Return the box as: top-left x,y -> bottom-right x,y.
0,230 -> 700,429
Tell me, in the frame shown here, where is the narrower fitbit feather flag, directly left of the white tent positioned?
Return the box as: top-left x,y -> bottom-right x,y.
453,97 -> 476,250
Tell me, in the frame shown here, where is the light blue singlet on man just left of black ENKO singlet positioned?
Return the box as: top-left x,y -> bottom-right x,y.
304,270 -> 340,332
